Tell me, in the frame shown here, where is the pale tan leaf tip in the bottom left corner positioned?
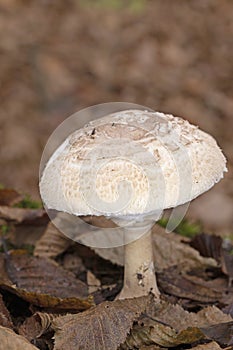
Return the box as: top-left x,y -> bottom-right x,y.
0,326 -> 38,350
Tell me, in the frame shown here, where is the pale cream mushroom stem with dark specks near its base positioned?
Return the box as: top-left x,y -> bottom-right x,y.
118,229 -> 160,299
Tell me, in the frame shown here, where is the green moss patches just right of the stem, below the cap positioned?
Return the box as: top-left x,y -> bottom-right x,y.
158,218 -> 202,238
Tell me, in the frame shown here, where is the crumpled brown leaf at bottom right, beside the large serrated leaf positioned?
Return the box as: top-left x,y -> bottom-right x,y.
122,301 -> 230,349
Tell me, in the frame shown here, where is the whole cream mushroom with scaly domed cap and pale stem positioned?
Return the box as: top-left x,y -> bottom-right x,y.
40,109 -> 227,298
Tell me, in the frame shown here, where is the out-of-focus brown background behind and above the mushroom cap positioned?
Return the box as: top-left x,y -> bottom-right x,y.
0,0 -> 233,233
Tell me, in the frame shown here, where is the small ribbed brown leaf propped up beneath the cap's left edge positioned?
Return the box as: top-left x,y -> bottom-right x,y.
34,222 -> 71,258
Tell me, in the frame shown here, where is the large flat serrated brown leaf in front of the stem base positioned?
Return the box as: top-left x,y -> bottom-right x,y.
53,296 -> 151,350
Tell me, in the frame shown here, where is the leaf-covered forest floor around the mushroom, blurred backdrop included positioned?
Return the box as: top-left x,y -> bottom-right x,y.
0,0 -> 233,350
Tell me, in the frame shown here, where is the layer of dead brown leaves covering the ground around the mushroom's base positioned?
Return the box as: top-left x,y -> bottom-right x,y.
0,186 -> 233,350
